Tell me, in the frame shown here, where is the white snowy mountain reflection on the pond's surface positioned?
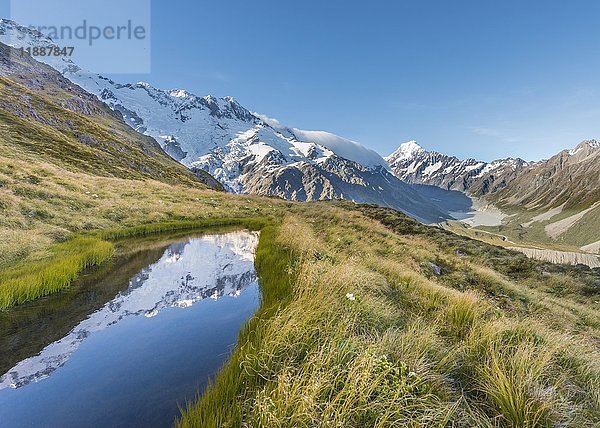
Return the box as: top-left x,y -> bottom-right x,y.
0,231 -> 258,390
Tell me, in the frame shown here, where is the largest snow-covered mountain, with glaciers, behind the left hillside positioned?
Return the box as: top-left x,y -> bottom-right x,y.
0,20 -> 448,222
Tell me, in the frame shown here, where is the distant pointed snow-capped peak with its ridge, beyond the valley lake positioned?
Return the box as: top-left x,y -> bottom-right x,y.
385,141 -> 530,196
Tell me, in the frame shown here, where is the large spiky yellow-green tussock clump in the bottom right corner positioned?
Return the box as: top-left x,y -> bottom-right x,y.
461,318 -> 568,427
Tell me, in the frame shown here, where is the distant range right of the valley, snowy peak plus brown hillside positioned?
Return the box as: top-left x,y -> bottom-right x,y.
385,140 -> 600,253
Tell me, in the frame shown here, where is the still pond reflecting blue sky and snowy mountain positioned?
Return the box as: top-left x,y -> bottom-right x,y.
0,231 -> 260,427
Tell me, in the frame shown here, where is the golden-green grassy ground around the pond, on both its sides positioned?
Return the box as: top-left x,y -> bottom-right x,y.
0,153 -> 600,427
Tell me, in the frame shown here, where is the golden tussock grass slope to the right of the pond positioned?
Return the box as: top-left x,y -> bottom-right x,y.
179,204 -> 600,427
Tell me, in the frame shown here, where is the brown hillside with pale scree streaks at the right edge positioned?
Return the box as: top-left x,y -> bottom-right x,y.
480,140 -> 600,254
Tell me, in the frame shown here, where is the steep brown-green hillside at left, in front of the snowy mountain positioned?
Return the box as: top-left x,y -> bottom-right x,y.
0,43 -> 221,186
